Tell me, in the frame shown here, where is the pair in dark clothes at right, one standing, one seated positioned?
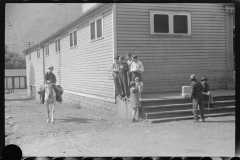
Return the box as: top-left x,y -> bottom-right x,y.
190,74 -> 215,122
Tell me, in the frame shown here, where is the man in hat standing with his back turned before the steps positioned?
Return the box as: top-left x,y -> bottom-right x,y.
190,74 -> 205,122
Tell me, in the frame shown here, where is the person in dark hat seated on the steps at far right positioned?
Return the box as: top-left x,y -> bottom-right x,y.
201,77 -> 214,108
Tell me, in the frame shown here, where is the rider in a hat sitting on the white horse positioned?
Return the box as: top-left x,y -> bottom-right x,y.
41,66 -> 62,104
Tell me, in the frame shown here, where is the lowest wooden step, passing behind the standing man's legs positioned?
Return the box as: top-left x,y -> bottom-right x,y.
143,106 -> 235,119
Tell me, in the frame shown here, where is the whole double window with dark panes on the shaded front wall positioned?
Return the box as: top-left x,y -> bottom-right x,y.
150,11 -> 191,35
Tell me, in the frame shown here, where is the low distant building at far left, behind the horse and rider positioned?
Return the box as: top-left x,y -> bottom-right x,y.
5,69 -> 27,89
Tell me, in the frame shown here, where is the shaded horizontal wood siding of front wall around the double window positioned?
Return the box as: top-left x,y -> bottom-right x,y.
116,3 -> 227,93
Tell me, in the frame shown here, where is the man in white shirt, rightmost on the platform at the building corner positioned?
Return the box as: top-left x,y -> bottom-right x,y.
131,55 -> 144,81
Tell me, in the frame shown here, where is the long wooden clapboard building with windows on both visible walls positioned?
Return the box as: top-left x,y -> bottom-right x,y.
24,3 -> 235,113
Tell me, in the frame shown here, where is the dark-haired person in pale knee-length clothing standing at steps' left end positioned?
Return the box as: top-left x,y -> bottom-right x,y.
130,81 -> 141,122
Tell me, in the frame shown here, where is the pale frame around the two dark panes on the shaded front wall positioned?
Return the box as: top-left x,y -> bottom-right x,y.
150,11 -> 192,36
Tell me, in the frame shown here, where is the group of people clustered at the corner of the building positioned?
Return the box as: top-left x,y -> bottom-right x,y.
111,53 -> 144,122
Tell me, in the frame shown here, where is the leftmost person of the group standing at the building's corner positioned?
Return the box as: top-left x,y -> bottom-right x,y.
111,56 -> 122,96
